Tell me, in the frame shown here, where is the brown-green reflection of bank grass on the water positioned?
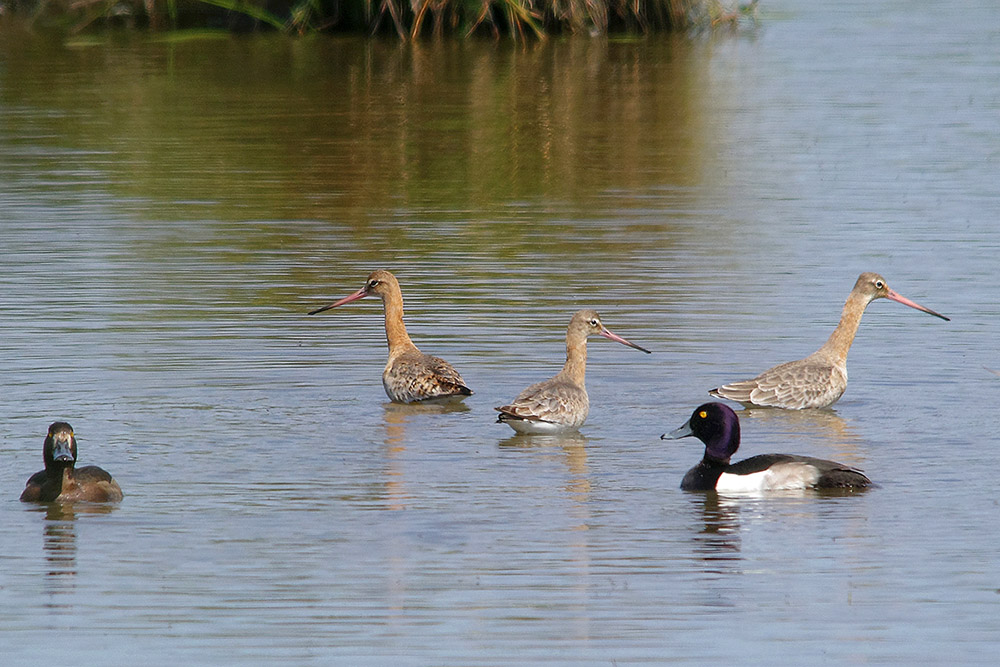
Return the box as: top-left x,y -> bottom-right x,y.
0,31 -> 713,226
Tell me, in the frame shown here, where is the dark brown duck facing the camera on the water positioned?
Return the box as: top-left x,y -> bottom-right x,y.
21,421 -> 124,503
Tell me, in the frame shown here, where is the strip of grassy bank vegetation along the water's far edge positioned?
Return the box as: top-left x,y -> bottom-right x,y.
0,0 -> 757,40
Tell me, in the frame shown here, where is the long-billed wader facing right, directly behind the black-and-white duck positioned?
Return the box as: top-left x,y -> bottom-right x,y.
708,273 -> 948,410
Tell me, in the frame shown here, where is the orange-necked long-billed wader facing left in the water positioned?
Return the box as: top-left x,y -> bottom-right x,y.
309,270 -> 472,403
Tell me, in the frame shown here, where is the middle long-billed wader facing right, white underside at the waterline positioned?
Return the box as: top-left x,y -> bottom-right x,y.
496,310 -> 650,433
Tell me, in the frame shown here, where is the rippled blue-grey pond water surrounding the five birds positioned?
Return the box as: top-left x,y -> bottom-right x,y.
0,0 -> 1000,665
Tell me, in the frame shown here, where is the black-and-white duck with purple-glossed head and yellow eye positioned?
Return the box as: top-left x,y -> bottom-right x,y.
660,403 -> 872,493
